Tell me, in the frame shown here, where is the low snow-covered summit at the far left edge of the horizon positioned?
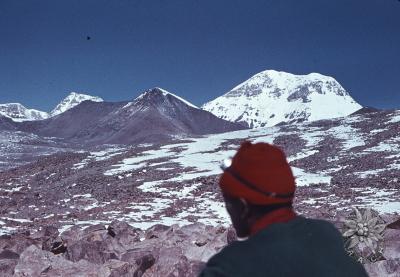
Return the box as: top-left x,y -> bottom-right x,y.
0,103 -> 49,122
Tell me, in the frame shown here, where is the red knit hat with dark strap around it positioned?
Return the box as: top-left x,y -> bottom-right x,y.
219,141 -> 296,205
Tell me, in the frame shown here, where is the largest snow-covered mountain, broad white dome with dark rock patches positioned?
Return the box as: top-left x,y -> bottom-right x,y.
202,70 -> 362,128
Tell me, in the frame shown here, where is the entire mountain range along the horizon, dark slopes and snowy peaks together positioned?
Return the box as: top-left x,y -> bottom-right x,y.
0,70 -> 362,144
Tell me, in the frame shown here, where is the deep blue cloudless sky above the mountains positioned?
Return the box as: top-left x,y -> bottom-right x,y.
0,0 -> 400,111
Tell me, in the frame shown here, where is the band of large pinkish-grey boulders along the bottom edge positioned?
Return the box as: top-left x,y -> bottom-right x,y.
0,217 -> 400,277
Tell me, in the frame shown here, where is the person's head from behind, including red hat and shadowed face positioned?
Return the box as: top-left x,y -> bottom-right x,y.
220,142 -> 295,237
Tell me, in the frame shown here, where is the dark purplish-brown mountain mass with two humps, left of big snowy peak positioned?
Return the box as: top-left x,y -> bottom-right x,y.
12,88 -> 245,145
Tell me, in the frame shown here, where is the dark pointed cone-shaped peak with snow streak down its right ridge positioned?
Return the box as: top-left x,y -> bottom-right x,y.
81,88 -> 244,144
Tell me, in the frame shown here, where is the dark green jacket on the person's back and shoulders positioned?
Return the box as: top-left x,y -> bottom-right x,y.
200,216 -> 368,277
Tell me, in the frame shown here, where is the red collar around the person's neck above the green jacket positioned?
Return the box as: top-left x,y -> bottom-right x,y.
250,207 -> 296,235
